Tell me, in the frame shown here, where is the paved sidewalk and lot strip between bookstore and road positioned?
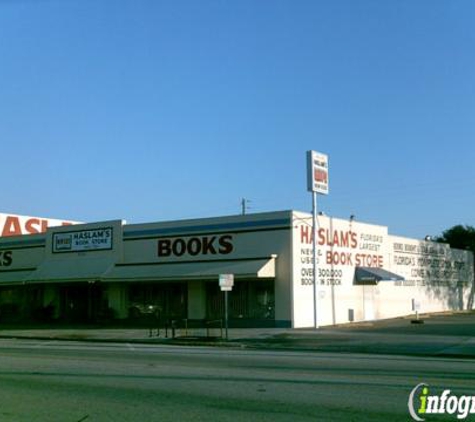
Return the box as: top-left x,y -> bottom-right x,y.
0,312 -> 475,359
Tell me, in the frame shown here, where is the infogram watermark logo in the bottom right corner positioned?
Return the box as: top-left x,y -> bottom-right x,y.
407,383 -> 475,422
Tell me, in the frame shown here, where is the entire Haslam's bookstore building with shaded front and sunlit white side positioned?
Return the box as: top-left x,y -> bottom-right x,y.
0,211 -> 475,328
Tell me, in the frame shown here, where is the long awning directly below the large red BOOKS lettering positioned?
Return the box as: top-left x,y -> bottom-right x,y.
103,258 -> 275,282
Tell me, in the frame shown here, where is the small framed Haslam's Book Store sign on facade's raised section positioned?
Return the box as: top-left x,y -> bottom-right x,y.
53,227 -> 113,253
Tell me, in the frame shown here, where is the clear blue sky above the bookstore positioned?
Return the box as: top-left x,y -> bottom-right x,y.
0,0 -> 475,237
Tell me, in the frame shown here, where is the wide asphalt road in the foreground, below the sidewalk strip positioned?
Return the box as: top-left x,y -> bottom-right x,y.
0,340 -> 475,422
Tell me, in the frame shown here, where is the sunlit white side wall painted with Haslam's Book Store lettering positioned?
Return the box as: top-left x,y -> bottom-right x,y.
292,212 -> 475,327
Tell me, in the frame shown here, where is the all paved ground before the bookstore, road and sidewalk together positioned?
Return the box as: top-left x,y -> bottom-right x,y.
0,313 -> 475,422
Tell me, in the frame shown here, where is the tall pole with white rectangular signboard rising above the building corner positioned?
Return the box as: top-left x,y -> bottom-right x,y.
307,151 -> 329,328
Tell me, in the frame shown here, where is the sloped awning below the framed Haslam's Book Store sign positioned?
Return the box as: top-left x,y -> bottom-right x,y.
26,257 -> 115,284
